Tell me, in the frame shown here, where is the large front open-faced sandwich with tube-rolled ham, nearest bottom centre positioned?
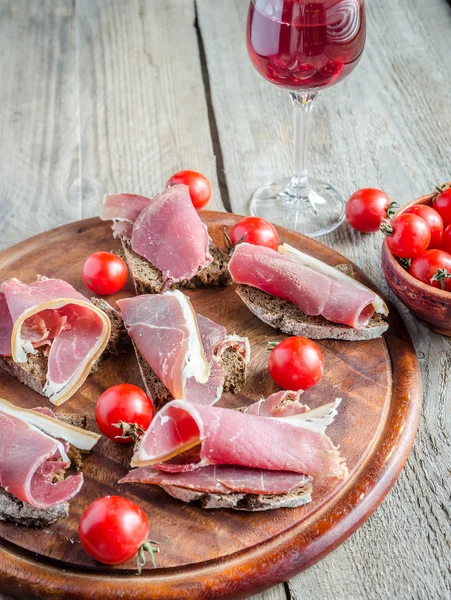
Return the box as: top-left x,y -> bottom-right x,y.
120,392 -> 348,510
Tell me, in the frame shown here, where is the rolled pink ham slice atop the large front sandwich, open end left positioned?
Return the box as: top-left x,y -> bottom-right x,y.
132,400 -> 347,478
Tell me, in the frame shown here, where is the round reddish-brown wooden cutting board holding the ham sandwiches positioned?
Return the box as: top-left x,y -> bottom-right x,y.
0,212 -> 422,600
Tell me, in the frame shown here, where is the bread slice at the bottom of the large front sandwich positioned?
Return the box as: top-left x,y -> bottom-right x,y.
162,478 -> 312,511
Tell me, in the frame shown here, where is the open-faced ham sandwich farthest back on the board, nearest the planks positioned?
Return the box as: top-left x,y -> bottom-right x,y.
100,184 -> 230,294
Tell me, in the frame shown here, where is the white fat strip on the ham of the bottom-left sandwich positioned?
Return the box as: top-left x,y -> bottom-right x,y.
0,398 -> 102,450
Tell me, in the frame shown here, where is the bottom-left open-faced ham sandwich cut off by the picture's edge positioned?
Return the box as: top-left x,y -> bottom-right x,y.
0,398 -> 100,527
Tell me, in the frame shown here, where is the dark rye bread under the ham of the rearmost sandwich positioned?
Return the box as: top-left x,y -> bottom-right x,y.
121,240 -> 232,294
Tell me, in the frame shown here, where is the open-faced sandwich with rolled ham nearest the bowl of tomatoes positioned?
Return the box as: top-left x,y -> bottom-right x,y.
229,243 -> 388,341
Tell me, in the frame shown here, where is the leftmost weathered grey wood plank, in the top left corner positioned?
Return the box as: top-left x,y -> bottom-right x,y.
0,0 -> 81,249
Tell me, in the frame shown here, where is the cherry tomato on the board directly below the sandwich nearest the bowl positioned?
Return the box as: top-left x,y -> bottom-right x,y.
268,336 -> 324,392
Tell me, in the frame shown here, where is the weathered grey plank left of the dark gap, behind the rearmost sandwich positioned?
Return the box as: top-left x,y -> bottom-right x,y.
77,0 -> 223,211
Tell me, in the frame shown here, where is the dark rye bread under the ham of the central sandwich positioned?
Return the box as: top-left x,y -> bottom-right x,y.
133,344 -> 246,411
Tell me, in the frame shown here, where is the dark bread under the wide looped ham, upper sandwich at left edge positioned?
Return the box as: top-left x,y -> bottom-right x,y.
0,298 -> 130,396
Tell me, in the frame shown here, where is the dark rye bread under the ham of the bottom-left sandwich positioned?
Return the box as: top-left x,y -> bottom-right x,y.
0,414 -> 86,529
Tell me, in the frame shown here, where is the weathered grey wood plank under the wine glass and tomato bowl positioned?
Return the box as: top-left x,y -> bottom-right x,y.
197,0 -> 451,599
